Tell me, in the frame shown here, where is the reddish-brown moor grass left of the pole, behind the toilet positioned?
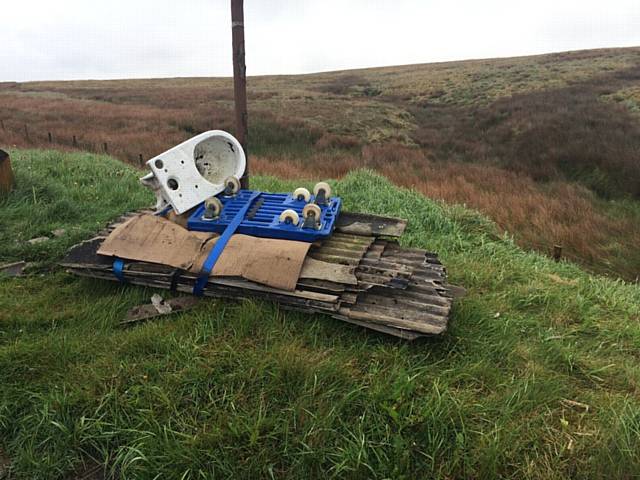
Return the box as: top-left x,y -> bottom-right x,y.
0,93 -> 233,163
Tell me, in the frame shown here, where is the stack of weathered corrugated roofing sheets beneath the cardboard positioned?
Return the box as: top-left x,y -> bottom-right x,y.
61,212 -> 456,340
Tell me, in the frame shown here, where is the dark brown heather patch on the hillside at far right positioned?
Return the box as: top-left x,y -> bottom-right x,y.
412,65 -> 640,198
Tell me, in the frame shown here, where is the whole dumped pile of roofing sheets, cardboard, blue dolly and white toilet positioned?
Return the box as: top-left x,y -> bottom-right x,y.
62,132 -> 456,340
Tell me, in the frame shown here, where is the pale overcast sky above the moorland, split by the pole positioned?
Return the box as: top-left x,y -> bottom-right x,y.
0,0 -> 640,81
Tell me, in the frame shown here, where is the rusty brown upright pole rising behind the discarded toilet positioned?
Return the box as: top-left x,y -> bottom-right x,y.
231,0 -> 249,188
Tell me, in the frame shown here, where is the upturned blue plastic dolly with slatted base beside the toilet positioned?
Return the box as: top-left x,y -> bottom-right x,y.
187,190 -> 342,242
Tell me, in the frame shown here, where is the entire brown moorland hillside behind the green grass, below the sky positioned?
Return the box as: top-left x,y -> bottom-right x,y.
0,48 -> 640,279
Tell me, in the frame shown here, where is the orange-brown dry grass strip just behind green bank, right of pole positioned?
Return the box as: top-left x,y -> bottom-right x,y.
252,145 -> 640,279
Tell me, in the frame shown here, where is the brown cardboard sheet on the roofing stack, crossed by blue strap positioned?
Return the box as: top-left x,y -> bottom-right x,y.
98,214 -> 310,291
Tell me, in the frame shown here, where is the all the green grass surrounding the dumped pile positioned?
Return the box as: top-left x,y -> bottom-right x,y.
0,151 -> 640,479
